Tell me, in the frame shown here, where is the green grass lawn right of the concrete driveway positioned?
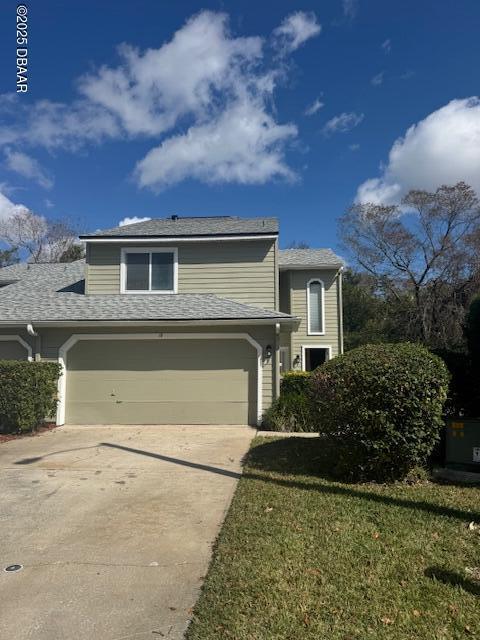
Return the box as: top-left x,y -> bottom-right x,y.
187,438 -> 480,640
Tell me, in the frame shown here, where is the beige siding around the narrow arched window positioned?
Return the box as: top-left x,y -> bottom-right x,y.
280,269 -> 340,367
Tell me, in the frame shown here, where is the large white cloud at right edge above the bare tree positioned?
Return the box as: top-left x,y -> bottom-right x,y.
357,97 -> 480,204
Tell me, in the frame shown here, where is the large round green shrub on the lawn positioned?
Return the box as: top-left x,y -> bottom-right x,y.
312,343 -> 449,481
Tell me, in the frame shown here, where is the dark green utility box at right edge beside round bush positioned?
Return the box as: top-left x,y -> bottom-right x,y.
445,418 -> 480,473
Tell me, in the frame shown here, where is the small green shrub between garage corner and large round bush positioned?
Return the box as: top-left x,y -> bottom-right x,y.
262,371 -> 315,432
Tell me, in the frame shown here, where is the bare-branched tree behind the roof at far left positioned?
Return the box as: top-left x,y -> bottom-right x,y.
0,210 -> 78,262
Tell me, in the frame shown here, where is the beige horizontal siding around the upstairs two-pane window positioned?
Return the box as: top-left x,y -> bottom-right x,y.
86,240 -> 276,309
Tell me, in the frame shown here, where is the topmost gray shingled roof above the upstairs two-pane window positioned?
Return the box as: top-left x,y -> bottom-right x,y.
80,216 -> 278,239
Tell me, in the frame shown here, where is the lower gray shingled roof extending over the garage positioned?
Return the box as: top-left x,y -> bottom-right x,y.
0,260 -> 291,324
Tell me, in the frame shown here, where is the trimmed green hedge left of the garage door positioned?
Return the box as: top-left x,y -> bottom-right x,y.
0,360 -> 60,433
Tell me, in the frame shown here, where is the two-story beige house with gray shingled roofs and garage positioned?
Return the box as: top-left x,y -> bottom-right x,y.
0,216 -> 342,424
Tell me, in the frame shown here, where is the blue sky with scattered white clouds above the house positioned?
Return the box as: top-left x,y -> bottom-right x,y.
0,0 -> 480,248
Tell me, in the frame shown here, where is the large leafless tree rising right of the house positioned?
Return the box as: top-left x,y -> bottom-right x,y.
340,182 -> 480,347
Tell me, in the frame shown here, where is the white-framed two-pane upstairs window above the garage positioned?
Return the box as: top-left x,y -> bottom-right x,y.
121,249 -> 178,293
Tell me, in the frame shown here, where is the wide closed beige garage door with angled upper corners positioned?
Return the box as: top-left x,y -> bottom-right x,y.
65,339 -> 257,424
